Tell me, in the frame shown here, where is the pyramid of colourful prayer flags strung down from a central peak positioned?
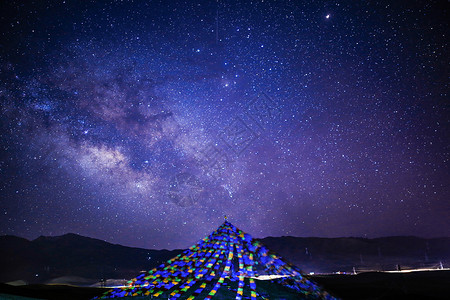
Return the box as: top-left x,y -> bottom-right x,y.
94,221 -> 336,300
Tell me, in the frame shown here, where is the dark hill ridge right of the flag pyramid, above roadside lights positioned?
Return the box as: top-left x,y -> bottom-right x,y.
260,236 -> 450,273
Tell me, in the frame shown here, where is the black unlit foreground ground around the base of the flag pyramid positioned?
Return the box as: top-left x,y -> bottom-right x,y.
0,271 -> 450,300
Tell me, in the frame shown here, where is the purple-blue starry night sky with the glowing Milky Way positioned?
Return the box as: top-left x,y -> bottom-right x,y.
0,0 -> 450,249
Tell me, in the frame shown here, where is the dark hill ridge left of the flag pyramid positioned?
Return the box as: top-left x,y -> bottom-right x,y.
0,233 -> 182,283
